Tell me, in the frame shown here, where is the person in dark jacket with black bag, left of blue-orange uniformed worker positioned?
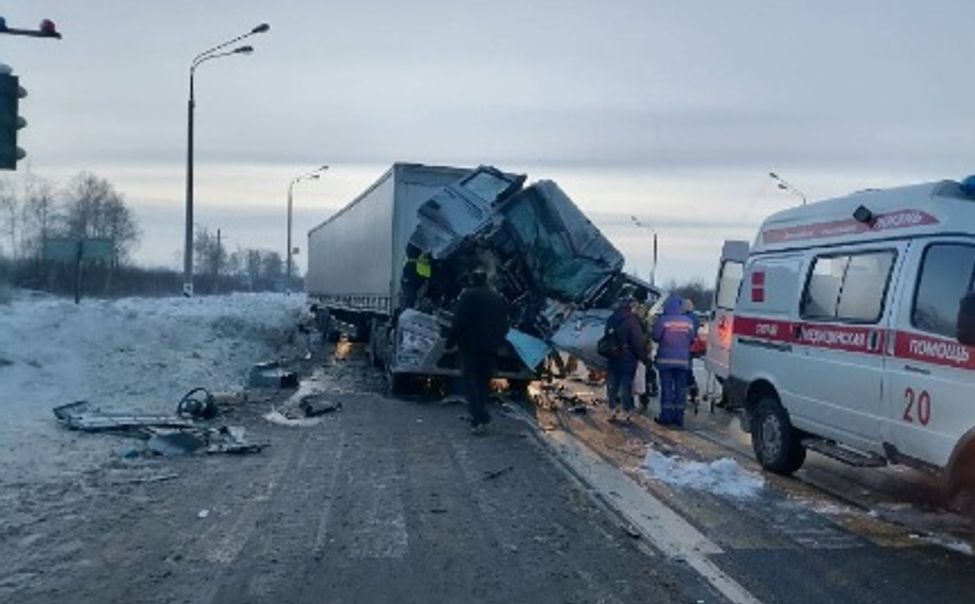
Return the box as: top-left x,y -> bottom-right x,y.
606,293 -> 647,422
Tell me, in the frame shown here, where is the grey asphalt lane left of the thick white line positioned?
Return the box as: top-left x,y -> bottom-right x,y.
0,354 -> 717,604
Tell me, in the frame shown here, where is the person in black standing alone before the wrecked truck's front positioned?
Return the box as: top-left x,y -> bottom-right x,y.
447,270 -> 510,435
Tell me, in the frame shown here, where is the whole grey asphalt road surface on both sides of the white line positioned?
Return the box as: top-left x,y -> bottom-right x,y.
0,346 -> 975,604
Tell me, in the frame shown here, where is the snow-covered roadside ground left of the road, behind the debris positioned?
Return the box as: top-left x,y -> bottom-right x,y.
0,291 -> 305,483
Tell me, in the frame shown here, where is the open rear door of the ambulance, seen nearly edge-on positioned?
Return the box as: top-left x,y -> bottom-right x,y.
704,241 -> 749,382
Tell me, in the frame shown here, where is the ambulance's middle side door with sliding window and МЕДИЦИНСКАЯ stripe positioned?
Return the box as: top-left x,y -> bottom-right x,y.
790,242 -> 906,452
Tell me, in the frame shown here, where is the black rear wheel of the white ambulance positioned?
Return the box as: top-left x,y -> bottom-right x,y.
752,396 -> 806,476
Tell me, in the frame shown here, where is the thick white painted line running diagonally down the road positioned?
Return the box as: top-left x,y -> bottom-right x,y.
541,431 -> 761,604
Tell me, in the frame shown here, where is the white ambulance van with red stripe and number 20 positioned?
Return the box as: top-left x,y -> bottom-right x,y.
726,176 -> 975,492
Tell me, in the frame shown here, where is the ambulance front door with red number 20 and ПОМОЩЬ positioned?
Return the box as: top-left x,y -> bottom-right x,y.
883,237 -> 975,467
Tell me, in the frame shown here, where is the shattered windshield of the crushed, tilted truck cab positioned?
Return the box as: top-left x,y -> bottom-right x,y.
502,182 -> 622,301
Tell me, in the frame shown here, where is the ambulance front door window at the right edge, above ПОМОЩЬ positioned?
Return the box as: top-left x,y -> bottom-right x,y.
911,244 -> 975,338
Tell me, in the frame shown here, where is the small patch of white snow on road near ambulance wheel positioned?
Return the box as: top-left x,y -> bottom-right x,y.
641,449 -> 765,499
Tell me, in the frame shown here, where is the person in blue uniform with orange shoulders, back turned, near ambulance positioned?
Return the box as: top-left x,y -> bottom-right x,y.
653,296 -> 695,427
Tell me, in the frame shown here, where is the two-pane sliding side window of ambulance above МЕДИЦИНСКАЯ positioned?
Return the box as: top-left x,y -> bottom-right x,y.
802,251 -> 894,323
